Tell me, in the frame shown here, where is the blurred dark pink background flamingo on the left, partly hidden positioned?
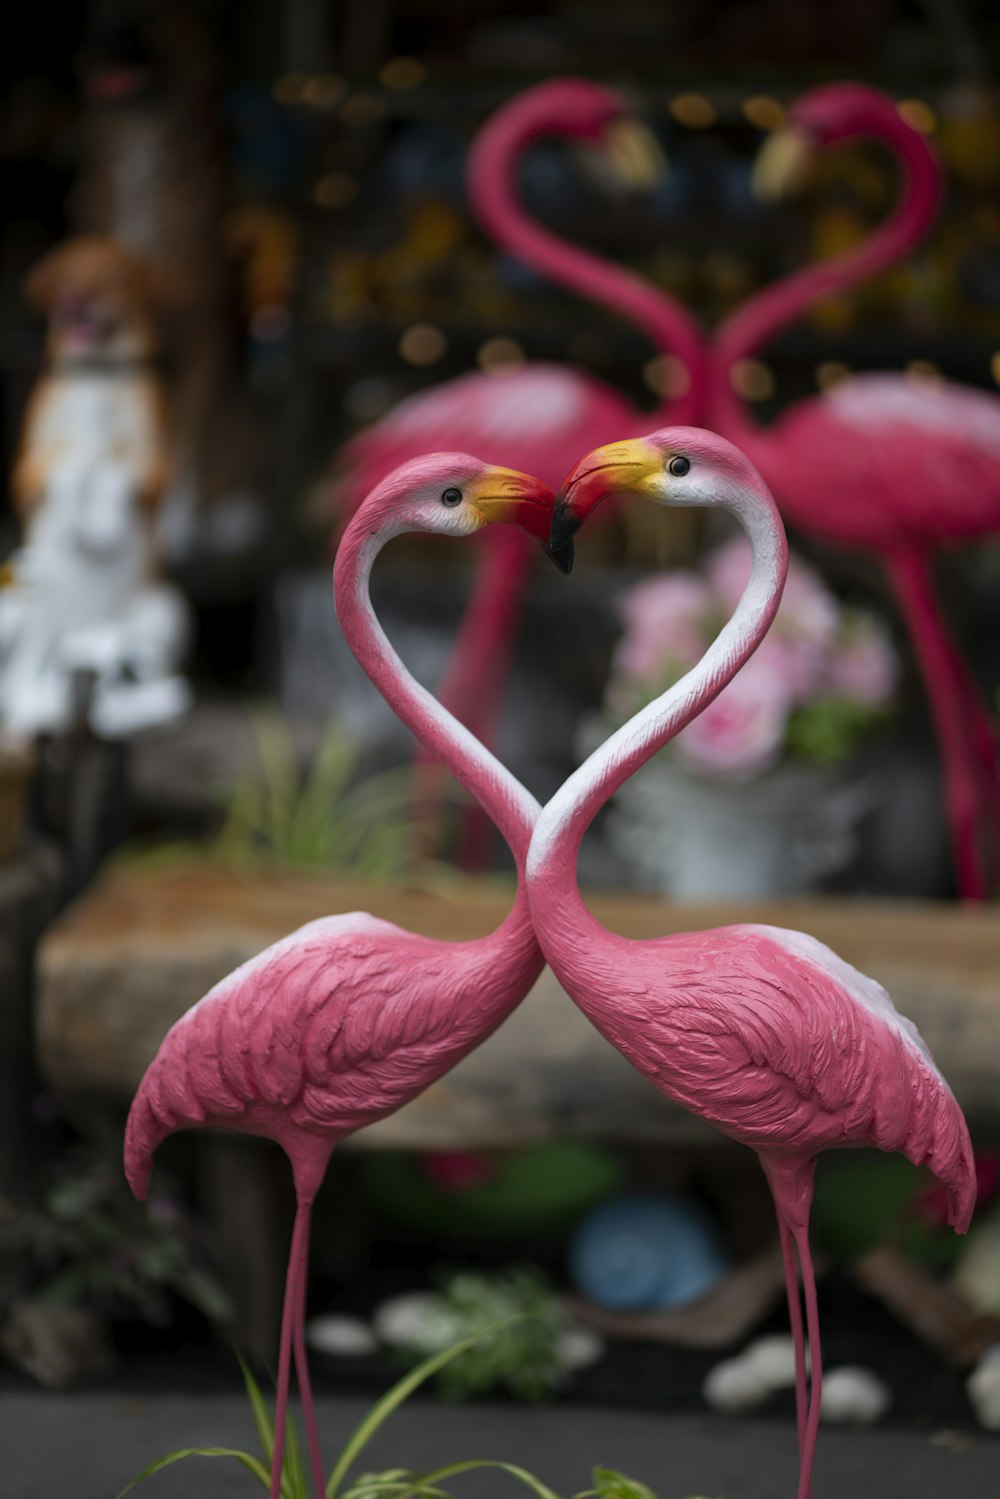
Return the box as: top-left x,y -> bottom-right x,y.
337,78 -> 705,863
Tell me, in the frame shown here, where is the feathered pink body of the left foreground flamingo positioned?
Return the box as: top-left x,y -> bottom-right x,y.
124,911 -> 540,1198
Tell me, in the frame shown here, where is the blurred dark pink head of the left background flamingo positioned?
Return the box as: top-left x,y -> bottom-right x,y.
469,78 -> 666,190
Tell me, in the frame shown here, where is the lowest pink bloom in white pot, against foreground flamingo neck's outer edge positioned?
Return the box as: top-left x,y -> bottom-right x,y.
675,654 -> 792,779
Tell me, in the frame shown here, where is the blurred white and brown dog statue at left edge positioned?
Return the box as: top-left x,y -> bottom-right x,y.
0,238 -> 189,739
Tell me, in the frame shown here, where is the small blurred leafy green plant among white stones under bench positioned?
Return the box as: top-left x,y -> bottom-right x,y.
395,1265 -> 565,1402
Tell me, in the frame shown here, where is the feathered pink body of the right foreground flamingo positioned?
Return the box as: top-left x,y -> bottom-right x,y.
543,925 -> 975,1234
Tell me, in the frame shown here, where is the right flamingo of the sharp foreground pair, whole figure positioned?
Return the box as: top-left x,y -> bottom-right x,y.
528,427 -> 976,1499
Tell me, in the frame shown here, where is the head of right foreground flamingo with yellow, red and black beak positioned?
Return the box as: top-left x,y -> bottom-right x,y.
550,427 -> 774,549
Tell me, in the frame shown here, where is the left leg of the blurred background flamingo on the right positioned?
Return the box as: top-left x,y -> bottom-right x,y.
886,552 -> 987,901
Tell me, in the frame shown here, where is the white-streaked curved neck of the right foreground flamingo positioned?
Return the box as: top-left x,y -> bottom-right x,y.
528,486 -> 789,947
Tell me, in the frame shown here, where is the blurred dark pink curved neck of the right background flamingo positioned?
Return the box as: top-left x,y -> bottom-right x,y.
712,109 -> 942,447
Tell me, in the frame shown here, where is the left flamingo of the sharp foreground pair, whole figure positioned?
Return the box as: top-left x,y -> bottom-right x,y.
124,453 -> 568,1499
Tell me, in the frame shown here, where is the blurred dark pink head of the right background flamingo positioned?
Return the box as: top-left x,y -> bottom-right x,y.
751,82 -> 916,202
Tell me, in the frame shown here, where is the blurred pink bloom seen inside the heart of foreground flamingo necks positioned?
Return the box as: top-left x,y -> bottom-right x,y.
612,573 -> 712,687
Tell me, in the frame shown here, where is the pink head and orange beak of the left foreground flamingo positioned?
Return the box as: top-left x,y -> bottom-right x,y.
367,453 -> 573,573
